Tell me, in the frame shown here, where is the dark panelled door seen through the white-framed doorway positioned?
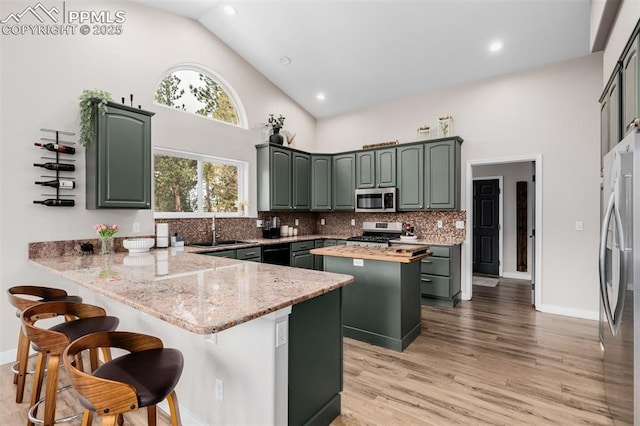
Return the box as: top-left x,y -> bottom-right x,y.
473,179 -> 500,275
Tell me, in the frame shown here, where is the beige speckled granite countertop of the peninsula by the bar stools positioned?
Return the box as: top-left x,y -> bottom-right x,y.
29,250 -> 353,334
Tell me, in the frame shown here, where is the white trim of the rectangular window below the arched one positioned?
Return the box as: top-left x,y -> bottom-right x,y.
152,147 -> 249,219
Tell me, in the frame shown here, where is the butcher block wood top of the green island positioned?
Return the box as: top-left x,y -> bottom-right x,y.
311,244 -> 431,263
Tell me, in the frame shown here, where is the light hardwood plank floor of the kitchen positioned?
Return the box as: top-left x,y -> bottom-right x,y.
0,279 -> 613,426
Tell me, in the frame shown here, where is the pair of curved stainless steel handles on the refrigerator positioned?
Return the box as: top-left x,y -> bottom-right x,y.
599,193 -> 627,336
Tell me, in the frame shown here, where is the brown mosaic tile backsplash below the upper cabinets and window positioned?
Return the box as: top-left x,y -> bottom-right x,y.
155,211 -> 467,244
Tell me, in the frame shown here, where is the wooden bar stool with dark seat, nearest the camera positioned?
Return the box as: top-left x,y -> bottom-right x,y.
62,331 -> 184,426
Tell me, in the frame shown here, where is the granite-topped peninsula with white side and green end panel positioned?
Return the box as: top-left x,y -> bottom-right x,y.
30,248 -> 353,425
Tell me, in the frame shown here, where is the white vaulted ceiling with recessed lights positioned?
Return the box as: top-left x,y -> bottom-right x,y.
134,0 -> 590,118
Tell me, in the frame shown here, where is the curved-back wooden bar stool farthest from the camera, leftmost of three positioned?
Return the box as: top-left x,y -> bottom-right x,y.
7,285 -> 82,403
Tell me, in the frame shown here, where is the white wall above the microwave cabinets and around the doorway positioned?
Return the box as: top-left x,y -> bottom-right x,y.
316,54 -> 602,318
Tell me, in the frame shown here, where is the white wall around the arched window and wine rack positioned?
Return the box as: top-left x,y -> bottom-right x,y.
0,0 -> 315,353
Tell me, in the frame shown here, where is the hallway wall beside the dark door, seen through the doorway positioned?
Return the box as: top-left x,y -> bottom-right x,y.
476,162 -> 533,278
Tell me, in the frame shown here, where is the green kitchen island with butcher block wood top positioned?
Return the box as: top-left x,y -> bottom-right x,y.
311,246 -> 431,352
